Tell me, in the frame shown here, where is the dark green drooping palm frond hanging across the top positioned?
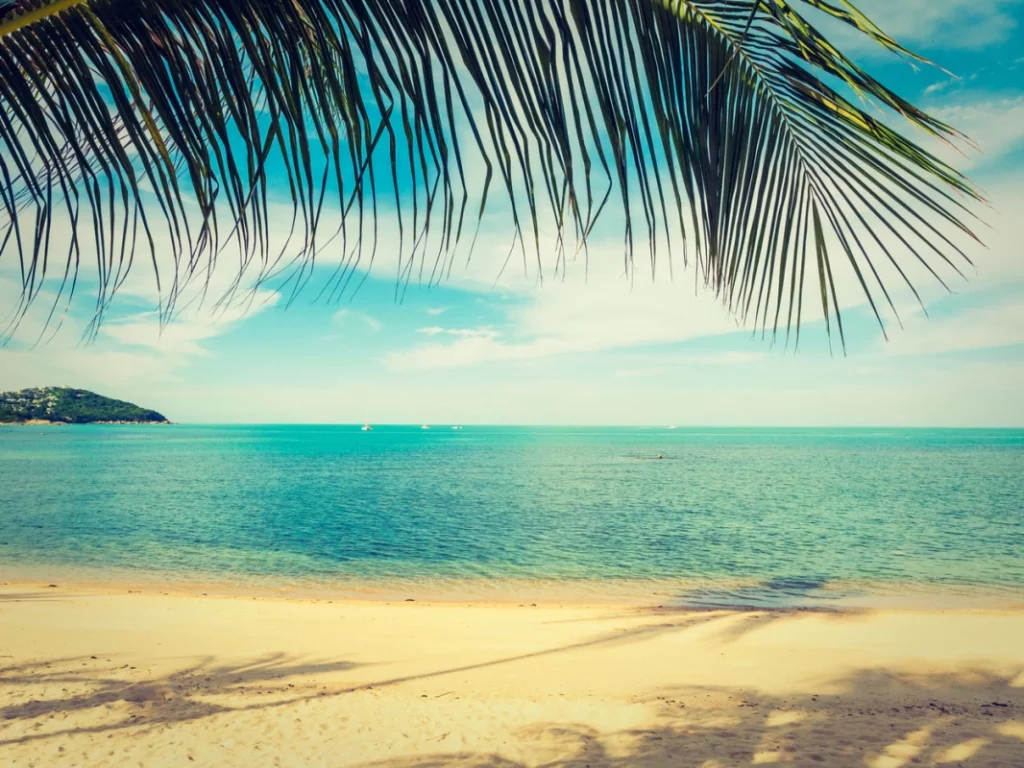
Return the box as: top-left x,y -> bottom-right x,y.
0,0 -> 978,346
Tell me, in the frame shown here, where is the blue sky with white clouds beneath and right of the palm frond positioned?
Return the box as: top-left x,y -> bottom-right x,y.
0,0 -> 1024,427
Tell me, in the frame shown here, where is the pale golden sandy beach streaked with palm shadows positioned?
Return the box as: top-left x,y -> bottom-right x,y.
0,585 -> 1024,768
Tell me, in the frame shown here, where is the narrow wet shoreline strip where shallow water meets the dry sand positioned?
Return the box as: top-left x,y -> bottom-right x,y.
6,564 -> 1024,612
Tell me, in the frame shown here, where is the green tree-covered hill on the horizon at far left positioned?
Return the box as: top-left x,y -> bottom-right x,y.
0,387 -> 168,424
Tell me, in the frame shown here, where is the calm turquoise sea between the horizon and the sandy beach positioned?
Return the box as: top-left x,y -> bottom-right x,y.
0,426 -> 1024,604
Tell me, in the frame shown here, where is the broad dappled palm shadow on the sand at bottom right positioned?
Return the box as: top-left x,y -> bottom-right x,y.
350,669 -> 1024,768
